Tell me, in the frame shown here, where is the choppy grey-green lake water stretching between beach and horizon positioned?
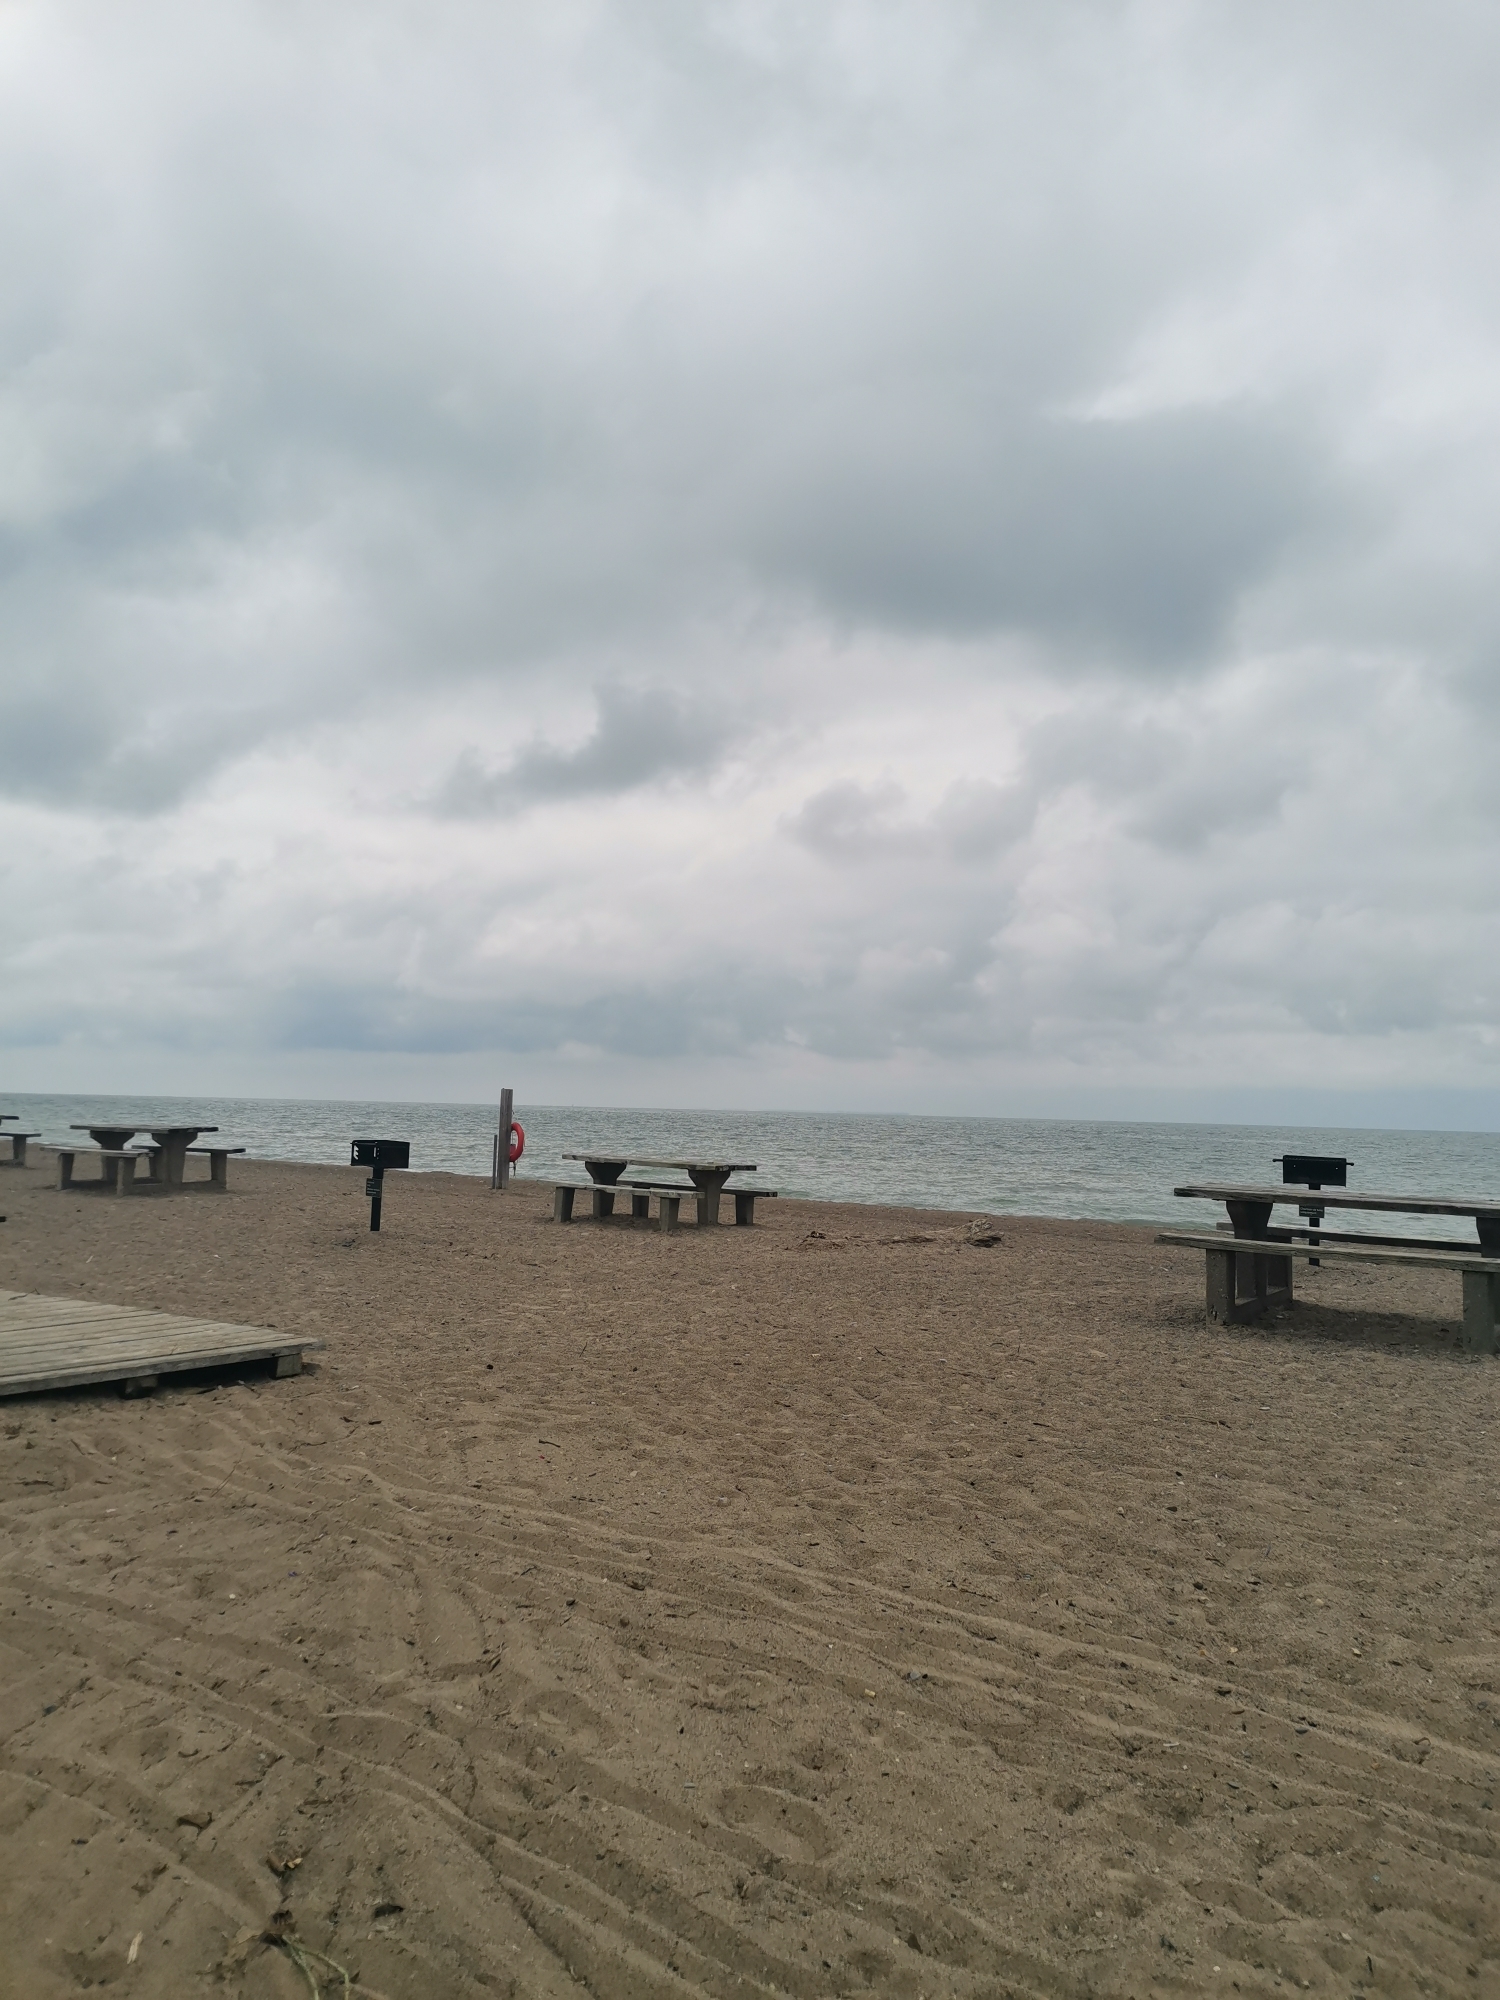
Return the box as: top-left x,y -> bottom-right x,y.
0,1094 -> 1500,1242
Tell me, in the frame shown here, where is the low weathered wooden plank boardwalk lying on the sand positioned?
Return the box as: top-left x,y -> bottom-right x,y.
0,1292 -> 324,1396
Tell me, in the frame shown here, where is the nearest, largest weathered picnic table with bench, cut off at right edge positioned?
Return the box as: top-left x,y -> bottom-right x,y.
1156,1182 -> 1500,1354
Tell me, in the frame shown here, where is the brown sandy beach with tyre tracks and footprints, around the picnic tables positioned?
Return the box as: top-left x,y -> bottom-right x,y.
0,1162 -> 1500,2000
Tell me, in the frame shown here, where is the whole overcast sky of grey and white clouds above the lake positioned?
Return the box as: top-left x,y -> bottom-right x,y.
0,0 -> 1500,1124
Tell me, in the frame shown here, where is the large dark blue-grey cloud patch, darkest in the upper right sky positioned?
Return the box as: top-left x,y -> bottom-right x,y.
758,410 -> 1338,666
